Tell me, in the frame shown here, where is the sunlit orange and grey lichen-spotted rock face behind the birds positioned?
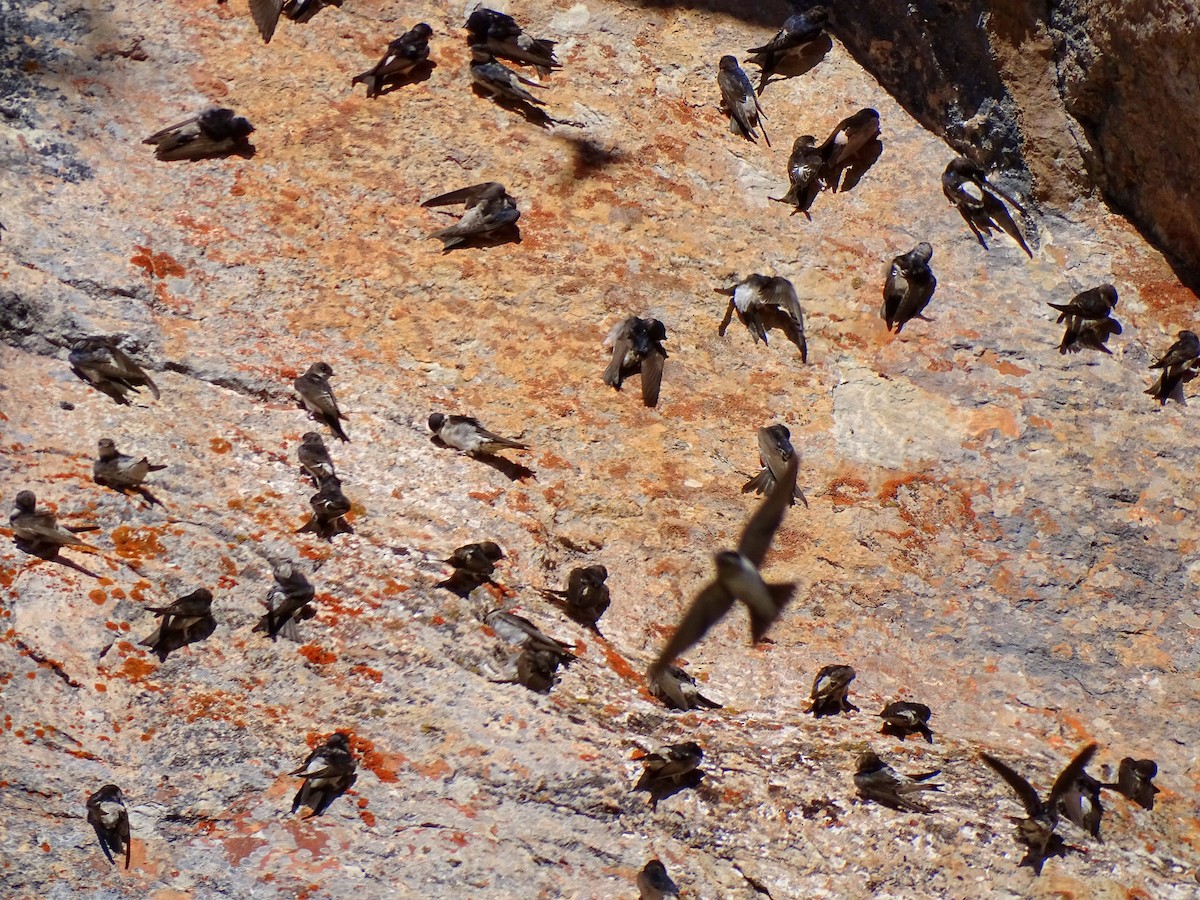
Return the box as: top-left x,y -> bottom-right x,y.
0,0 -> 1200,898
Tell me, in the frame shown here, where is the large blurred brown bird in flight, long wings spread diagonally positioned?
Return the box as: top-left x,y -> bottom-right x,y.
647,456 -> 799,682
